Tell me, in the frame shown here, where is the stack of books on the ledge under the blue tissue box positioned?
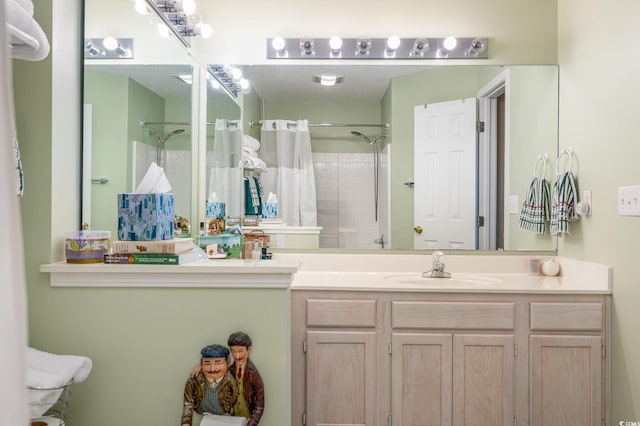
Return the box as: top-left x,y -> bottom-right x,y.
104,238 -> 200,265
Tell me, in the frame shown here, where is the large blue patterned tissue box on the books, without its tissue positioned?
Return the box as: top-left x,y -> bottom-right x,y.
118,194 -> 174,241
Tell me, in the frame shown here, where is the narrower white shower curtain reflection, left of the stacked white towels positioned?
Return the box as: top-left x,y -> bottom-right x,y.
207,119 -> 243,218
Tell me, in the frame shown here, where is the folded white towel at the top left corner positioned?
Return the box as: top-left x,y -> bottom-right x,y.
3,0 -> 50,61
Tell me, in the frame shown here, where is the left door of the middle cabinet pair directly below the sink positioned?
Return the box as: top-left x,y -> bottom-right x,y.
391,333 -> 452,426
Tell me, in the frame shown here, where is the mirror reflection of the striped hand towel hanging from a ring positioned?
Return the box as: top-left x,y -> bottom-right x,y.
520,154 -> 550,235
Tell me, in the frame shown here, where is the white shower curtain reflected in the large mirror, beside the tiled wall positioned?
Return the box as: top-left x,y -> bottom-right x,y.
260,120 -> 318,226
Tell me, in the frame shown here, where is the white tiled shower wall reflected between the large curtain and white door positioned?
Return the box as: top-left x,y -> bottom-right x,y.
313,149 -> 389,249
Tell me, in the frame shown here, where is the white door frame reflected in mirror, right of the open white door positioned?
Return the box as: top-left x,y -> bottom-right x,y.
477,69 -> 511,250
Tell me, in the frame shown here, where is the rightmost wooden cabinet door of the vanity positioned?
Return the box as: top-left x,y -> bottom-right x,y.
530,335 -> 603,426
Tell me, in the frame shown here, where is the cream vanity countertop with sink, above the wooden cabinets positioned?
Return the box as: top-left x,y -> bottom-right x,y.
277,254 -> 612,294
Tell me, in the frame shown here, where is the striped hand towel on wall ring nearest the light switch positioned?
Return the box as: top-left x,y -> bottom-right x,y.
549,148 -> 579,236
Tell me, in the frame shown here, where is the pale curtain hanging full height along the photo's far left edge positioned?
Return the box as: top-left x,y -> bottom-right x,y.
0,1 -> 31,425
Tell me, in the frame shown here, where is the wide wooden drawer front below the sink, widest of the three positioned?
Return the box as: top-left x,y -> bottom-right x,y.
391,302 -> 515,330
